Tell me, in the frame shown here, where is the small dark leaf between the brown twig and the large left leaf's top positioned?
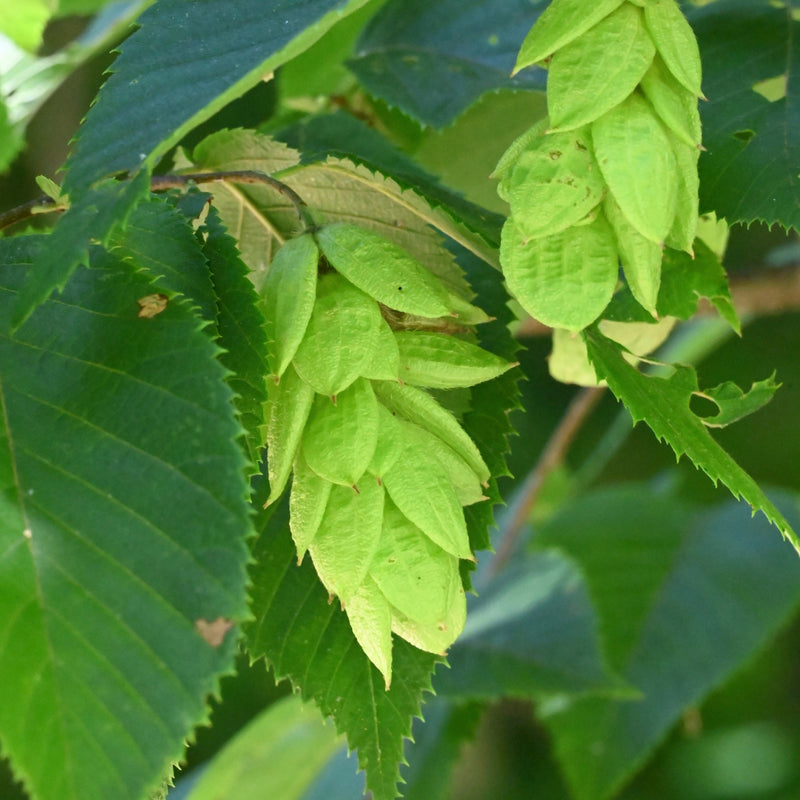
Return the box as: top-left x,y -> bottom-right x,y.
108,197 -> 217,323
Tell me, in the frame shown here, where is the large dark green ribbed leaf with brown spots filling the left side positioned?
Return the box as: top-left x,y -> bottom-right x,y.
0,237 -> 252,800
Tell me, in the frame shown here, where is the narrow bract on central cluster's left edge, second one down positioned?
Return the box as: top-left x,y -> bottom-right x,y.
267,366 -> 314,505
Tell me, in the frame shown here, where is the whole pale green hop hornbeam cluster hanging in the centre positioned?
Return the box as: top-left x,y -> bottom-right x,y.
263,223 -> 513,686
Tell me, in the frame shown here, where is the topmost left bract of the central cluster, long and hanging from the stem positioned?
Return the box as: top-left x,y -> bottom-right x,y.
261,234 -> 319,377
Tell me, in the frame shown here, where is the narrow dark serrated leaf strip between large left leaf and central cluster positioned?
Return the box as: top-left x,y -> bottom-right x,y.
202,208 -> 269,469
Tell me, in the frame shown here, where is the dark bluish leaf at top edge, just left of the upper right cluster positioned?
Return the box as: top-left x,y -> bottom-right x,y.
347,0 -> 545,128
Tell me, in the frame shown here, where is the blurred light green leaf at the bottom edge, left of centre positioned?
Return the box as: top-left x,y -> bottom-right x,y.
187,697 -> 343,800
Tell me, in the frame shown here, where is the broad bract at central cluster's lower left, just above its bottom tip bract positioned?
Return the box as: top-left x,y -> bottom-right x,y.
308,480 -> 384,607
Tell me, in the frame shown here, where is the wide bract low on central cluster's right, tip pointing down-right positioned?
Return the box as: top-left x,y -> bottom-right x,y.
383,439 -> 472,559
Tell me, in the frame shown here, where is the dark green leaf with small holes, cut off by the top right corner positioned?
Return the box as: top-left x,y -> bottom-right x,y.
690,0 -> 800,229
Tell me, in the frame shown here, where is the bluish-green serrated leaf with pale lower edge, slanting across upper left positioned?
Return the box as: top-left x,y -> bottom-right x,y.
64,0 -> 376,199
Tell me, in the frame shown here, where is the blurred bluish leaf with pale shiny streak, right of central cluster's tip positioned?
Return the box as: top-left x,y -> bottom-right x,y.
435,553 -> 621,700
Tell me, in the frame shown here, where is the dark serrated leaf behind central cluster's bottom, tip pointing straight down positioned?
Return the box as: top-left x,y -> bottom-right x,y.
246,494 -> 439,800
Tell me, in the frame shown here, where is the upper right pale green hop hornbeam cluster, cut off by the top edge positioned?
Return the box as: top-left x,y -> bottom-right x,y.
494,0 -> 702,331
